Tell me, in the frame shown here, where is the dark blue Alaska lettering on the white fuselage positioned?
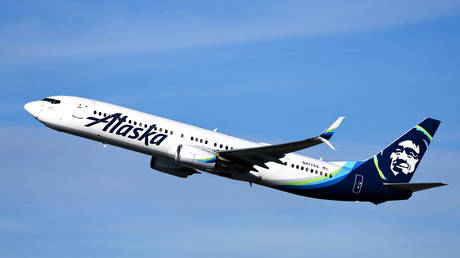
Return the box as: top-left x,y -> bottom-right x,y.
85,113 -> 168,146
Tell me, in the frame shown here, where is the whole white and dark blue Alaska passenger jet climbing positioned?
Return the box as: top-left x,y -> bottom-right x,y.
24,96 -> 446,205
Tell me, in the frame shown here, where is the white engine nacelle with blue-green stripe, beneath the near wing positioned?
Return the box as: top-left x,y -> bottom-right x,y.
176,144 -> 217,170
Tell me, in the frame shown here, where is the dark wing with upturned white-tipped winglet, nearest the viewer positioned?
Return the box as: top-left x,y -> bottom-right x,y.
218,117 -> 344,168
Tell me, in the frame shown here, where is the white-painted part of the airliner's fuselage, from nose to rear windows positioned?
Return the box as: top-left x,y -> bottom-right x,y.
25,96 -> 343,186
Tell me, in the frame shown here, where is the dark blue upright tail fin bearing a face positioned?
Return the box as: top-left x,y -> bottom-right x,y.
371,118 -> 441,183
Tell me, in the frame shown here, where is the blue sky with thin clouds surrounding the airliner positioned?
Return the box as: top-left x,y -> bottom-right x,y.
0,1 -> 460,257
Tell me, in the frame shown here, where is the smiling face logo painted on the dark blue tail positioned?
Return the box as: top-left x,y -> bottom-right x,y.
390,140 -> 420,176
